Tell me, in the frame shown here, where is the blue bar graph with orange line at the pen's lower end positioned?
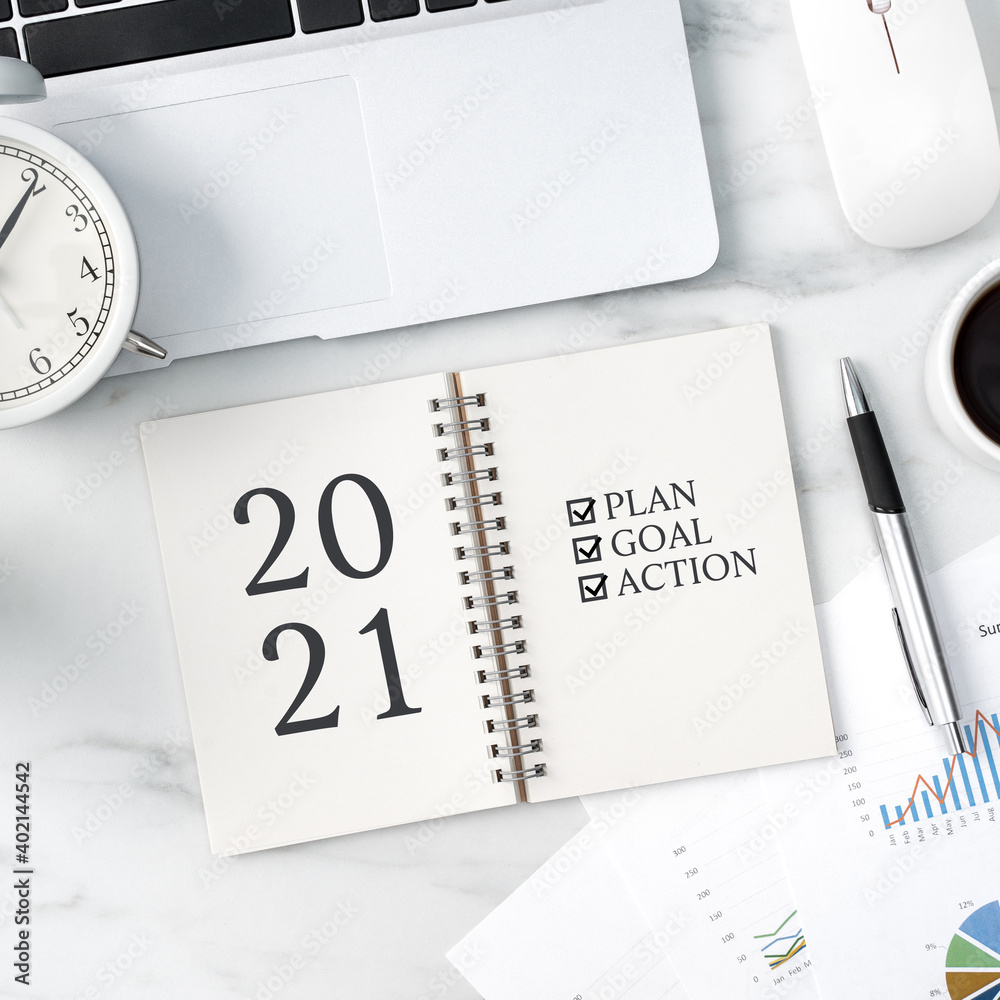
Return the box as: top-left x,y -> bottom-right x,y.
879,710 -> 1000,830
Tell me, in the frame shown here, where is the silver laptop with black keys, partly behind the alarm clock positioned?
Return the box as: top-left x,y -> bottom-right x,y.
0,0 -> 718,371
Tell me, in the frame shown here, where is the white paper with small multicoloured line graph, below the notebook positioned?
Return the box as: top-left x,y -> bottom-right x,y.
582,762 -> 823,1000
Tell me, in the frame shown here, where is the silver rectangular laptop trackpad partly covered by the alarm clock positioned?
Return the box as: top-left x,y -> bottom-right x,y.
54,77 -> 391,337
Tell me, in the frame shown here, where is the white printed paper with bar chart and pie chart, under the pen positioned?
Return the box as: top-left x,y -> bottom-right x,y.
764,539 -> 1000,1000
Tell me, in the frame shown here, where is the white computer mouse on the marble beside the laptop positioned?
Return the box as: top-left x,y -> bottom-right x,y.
791,0 -> 1000,248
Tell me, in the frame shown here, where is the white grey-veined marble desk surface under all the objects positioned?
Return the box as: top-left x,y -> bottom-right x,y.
0,0 -> 1000,1000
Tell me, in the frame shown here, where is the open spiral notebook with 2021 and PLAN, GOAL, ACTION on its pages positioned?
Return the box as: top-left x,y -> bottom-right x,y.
143,325 -> 834,853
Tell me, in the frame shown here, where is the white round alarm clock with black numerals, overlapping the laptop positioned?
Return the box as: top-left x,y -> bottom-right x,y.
0,59 -> 166,428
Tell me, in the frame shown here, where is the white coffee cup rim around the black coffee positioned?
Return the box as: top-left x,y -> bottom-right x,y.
924,260 -> 1000,471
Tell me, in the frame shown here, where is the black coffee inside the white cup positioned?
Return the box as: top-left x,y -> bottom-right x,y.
954,285 -> 1000,444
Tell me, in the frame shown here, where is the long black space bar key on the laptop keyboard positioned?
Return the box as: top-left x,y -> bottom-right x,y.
24,0 -> 295,76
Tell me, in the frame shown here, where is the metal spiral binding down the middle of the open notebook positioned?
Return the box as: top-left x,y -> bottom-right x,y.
430,374 -> 545,801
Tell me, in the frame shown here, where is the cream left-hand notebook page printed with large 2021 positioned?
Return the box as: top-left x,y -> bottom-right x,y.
143,376 -> 514,852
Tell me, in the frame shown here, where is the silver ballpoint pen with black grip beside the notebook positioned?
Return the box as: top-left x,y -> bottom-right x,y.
840,358 -> 967,754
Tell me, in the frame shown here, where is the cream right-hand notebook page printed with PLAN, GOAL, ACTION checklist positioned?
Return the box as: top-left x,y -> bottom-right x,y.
463,325 -> 834,801
